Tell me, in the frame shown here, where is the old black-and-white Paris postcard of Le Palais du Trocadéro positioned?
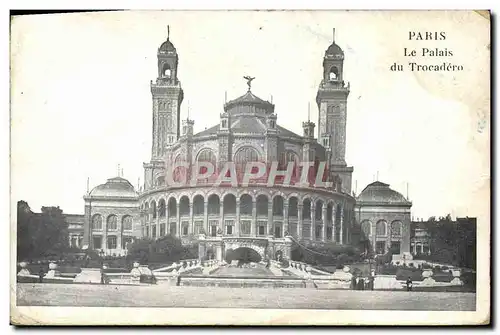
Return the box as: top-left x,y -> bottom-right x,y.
10,11 -> 491,325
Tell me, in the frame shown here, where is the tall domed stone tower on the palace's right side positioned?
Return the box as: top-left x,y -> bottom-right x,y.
316,29 -> 352,193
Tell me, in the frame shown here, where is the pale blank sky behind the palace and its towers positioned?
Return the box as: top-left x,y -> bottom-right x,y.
11,11 -> 490,219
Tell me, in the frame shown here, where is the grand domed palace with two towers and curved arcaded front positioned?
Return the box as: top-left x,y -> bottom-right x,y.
76,29 -> 411,259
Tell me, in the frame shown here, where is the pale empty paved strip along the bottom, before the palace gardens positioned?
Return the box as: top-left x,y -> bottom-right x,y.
17,284 -> 476,311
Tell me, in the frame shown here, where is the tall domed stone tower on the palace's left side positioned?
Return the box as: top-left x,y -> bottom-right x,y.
151,27 -> 184,160
